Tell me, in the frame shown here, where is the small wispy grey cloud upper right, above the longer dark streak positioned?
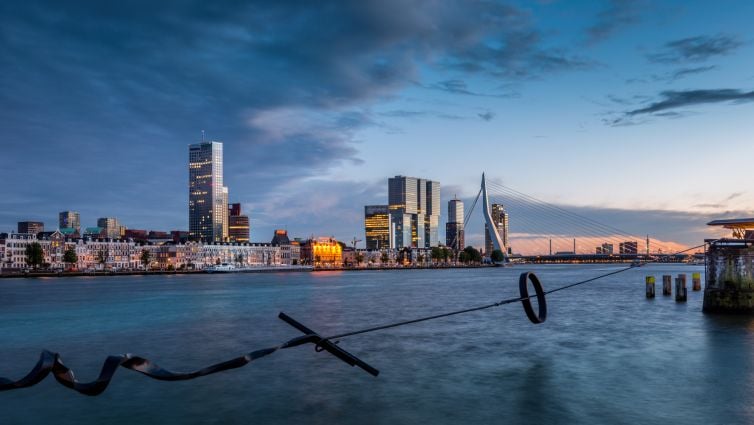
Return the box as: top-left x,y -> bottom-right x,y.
647,34 -> 743,63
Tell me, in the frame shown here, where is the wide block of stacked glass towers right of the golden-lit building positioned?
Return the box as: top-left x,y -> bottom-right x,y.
388,176 -> 440,248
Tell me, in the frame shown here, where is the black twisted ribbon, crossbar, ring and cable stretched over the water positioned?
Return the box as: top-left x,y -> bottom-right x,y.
0,244 -> 706,396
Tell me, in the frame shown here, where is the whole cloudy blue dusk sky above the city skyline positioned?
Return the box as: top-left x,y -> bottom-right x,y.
0,0 -> 754,245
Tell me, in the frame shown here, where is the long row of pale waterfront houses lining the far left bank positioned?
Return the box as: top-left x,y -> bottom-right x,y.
0,230 -> 458,272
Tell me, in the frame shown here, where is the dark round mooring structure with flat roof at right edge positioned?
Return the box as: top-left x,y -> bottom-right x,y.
702,218 -> 754,314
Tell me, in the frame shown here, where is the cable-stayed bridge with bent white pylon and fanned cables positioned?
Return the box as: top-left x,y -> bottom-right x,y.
464,174 -> 687,262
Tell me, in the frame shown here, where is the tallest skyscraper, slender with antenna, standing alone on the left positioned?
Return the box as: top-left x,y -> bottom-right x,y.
189,142 -> 223,242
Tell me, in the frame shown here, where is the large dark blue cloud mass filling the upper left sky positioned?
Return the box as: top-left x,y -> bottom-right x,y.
0,0 -> 589,232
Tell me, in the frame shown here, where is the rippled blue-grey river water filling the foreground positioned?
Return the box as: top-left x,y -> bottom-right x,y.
0,265 -> 754,424
